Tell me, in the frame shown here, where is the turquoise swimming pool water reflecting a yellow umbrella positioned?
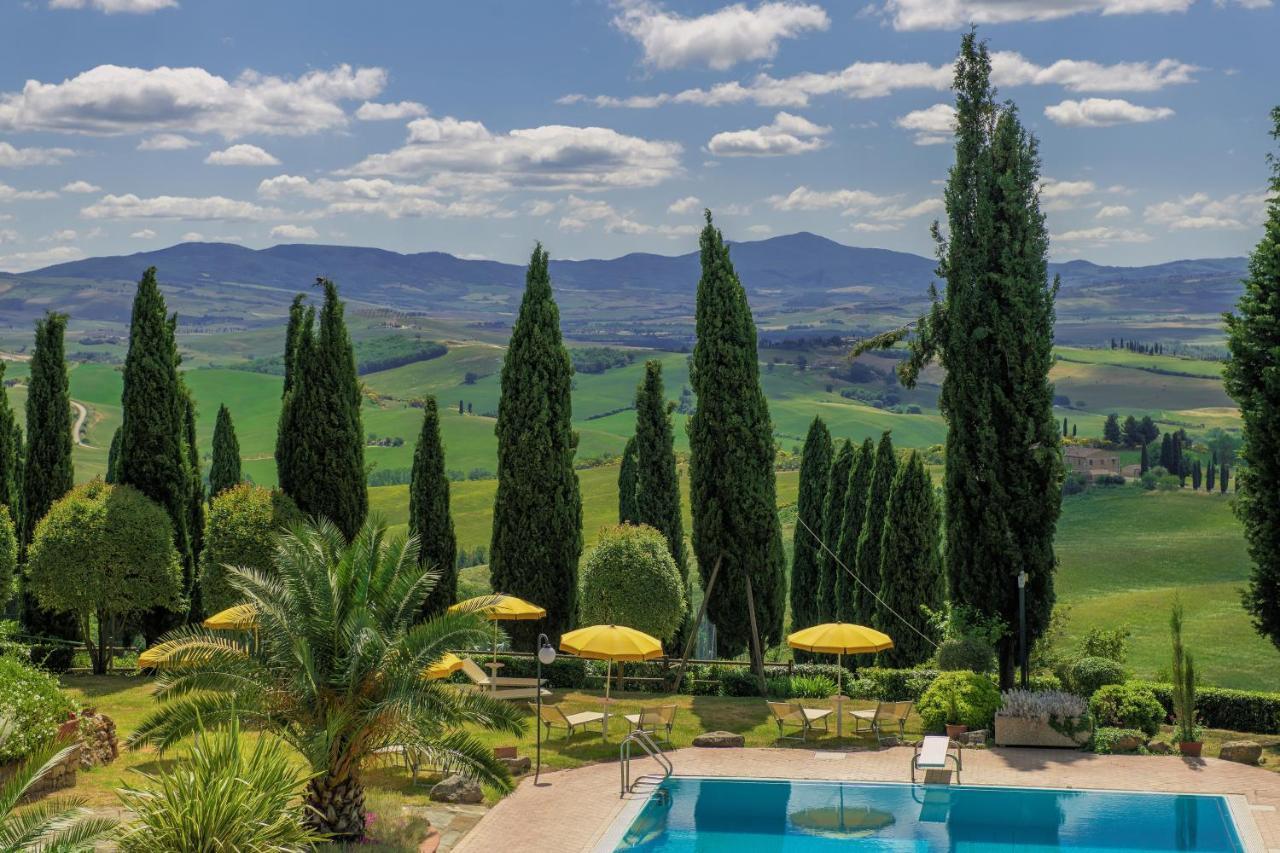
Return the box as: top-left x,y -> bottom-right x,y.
616,777 -> 1243,853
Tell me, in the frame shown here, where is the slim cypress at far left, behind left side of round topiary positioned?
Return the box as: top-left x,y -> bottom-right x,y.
19,313 -> 79,639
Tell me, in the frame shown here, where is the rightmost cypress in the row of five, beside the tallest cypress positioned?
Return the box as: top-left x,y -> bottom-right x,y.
876,451 -> 946,667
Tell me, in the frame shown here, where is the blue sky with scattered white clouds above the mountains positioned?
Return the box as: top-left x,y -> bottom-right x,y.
0,0 -> 1280,270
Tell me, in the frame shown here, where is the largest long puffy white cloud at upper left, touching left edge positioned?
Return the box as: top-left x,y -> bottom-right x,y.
0,65 -> 387,140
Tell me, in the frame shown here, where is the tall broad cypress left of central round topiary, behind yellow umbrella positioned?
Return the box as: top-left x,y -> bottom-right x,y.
489,243 -> 582,648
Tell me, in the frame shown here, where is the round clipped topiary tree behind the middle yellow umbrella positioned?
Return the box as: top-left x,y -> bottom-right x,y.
579,524 -> 687,640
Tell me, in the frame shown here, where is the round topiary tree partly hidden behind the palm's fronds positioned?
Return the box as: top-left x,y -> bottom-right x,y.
200,483 -> 303,613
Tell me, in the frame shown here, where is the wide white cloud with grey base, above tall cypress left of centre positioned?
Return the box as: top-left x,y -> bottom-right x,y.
346,117 -> 681,190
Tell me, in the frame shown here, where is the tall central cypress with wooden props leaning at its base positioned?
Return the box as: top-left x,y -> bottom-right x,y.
689,210 -> 786,657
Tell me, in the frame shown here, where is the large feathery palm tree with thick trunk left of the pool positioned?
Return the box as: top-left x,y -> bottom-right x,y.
129,521 -> 525,840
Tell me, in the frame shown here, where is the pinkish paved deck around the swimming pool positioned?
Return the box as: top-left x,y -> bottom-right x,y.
453,747 -> 1280,853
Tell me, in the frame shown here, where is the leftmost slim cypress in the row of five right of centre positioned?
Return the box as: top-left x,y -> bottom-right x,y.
791,418 -> 832,630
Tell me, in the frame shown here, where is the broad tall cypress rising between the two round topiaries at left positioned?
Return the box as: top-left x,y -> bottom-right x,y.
116,266 -> 197,642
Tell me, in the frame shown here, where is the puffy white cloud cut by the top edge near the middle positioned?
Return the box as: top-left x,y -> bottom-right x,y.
613,0 -> 831,70
